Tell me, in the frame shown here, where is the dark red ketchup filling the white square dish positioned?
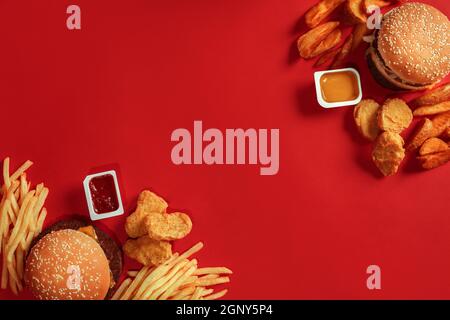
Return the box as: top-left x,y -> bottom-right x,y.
89,174 -> 119,213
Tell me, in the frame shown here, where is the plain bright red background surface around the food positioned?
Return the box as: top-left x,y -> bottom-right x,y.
0,0 -> 450,299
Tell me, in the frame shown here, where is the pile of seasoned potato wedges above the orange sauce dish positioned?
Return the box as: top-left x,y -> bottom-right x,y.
297,0 -> 397,69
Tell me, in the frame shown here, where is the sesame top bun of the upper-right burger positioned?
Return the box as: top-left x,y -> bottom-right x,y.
378,2 -> 450,85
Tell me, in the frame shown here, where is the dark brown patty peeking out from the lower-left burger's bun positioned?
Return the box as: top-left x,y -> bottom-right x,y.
30,219 -> 123,298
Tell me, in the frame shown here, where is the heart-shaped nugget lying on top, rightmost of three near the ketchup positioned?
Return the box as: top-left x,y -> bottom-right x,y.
145,212 -> 192,241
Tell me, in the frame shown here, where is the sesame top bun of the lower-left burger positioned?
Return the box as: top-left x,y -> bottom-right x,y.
25,229 -> 111,300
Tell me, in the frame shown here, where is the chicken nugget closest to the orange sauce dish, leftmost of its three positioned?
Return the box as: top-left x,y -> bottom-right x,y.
353,99 -> 380,141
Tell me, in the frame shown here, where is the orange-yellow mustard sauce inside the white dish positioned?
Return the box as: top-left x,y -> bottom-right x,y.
320,71 -> 359,102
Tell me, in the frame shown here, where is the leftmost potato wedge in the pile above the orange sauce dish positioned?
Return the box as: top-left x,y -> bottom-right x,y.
297,21 -> 339,59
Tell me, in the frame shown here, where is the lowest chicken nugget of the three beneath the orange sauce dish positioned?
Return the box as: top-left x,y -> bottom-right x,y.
372,131 -> 405,176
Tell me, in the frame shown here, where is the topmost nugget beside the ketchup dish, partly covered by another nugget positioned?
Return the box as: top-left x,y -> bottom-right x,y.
125,190 -> 168,238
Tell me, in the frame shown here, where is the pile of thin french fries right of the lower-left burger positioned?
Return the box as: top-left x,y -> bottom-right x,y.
111,242 -> 232,300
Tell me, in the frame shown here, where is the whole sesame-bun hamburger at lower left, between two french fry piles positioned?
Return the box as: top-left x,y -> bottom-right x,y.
25,220 -> 122,300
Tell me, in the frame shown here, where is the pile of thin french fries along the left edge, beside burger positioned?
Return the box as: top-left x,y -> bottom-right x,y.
0,158 -> 48,295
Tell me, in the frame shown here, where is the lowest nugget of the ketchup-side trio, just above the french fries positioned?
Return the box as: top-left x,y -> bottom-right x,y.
123,236 -> 172,266
